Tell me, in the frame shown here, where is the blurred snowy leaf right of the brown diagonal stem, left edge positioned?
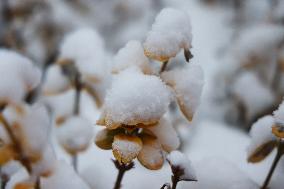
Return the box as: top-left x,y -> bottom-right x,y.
3,105 -> 50,162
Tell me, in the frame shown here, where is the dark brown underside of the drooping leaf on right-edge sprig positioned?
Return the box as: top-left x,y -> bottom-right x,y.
248,141 -> 277,163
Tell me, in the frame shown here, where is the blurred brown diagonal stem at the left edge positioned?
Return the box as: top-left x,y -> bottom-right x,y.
0,113 -> 32,173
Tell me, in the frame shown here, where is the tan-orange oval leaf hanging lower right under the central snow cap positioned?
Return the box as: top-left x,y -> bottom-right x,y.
138,135 -> 164,170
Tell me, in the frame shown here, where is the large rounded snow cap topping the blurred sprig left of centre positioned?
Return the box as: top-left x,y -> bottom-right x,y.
58,28 -> 106,81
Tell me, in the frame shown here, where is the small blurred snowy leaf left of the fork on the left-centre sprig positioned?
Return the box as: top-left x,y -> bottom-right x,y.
42,64 -> 70,95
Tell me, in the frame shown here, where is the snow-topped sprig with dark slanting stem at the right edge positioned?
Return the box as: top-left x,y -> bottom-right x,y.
248,102 -> 284,189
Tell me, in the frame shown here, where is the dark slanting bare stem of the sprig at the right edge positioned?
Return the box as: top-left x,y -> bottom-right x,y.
261,139 -> 284,189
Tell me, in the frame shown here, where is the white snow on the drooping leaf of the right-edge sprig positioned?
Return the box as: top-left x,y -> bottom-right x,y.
248,116 -> 277,161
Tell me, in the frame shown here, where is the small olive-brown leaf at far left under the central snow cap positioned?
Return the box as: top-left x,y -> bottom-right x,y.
95,129 -> 123,150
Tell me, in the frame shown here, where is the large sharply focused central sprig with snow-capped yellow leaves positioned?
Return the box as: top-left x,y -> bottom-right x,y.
95,9 -> 203,189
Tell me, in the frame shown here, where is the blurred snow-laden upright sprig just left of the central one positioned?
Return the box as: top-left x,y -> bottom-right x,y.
43,28 -> 104,170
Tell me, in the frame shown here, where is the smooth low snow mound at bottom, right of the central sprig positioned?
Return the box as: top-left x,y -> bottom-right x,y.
188,157 -> 259,189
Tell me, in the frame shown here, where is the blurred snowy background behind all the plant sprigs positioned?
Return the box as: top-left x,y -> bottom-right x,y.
0,0 -> 284,188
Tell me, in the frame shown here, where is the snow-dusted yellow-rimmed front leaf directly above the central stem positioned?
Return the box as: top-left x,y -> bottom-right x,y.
112,134 -> 142,164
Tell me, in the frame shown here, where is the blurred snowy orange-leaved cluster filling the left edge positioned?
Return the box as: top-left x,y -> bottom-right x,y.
0,49 -> 56,189
